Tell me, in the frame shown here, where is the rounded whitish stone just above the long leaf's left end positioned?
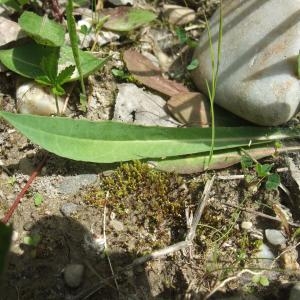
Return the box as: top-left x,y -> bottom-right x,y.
16,82 -> 69,116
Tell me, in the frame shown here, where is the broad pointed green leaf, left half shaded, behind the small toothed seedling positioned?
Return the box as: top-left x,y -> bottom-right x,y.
0,43 -> 106,81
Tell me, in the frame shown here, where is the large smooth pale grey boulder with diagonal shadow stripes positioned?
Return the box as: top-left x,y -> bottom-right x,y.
192,0 -> 300,125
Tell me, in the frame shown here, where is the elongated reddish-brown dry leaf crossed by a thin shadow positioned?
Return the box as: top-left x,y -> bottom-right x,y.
123,50 -> 189,97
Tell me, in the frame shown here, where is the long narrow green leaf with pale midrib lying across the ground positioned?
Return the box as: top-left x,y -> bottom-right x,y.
0,112 -> 299,163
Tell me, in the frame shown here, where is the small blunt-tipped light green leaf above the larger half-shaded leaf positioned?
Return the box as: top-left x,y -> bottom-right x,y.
19,11 -> 65,47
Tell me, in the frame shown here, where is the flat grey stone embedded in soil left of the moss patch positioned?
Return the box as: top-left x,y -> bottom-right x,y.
57,174 -> 97,195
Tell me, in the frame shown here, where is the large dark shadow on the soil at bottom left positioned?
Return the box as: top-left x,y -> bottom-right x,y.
0,216 -> 152,300
